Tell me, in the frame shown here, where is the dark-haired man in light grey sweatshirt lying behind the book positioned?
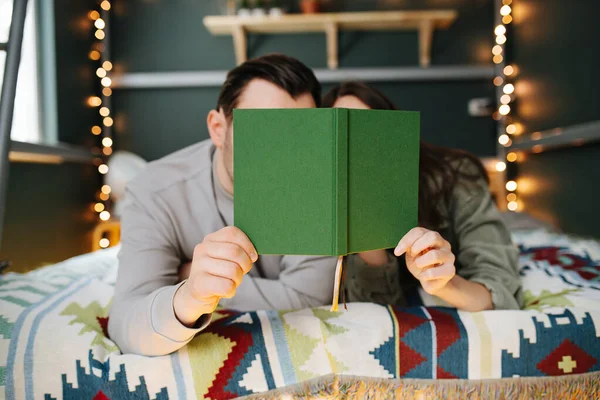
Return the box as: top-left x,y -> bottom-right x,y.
108,55 -> 336,355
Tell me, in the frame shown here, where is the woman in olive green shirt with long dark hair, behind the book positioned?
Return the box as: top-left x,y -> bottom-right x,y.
323,82 -> 522,311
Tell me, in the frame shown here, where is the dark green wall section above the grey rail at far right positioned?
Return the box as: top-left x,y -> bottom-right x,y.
511,0 -> 600,132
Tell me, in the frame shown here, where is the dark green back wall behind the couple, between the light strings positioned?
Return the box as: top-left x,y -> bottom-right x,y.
111,0 -> 495,159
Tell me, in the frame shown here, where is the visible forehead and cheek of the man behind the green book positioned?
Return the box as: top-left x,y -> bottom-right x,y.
222,79 -> 316,188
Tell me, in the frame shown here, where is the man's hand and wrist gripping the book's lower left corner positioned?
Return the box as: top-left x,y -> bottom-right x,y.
173,226 -> 258,327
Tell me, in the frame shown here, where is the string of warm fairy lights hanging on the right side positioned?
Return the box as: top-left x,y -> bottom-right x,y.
492,0 -> 521,211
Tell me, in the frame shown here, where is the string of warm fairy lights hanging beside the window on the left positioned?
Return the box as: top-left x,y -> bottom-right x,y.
87,0 -> 114,248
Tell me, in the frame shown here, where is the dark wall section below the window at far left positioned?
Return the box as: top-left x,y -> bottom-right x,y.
0,163 -> 100,272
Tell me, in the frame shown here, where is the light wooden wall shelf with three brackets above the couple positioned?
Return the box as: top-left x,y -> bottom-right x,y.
204,10 -> 458,69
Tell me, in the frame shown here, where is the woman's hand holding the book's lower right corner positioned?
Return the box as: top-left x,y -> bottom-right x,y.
394,228 -> 456,295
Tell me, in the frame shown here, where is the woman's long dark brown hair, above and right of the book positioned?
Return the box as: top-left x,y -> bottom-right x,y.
322,82 -> 488,229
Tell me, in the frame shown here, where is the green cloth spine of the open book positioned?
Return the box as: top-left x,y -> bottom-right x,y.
333,108 -> 349,255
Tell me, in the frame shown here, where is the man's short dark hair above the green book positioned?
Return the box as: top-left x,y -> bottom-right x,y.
217,54 -> 321,118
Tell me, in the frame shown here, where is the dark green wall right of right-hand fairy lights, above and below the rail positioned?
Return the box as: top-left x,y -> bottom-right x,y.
512,0 -> 600,237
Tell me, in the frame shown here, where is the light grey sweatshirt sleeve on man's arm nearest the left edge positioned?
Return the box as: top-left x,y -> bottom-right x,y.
108,188 -> 210,356
